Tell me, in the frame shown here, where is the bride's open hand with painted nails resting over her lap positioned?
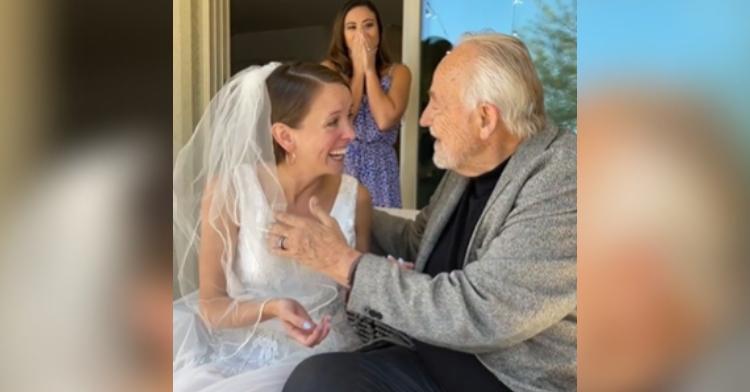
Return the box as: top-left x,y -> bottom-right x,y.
269,298 -> 331,347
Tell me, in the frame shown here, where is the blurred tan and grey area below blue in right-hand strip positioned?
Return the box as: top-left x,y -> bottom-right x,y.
578,80 -> 750,392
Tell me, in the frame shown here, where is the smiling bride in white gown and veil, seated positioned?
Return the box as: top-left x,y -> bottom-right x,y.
173,63 -> 372,392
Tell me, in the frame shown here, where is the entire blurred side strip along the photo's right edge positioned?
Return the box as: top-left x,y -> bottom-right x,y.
578,0 -> 750,392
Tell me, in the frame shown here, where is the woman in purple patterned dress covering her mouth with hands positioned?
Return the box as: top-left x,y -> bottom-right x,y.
323,0 -> 411,208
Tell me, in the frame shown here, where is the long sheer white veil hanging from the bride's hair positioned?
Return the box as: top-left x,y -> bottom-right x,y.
173,63 -> 286,370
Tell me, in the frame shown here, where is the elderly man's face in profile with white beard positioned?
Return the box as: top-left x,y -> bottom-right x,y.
419,45 -> 482,173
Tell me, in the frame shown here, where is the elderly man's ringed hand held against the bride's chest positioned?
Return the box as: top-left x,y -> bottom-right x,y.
268,197 -> 360,286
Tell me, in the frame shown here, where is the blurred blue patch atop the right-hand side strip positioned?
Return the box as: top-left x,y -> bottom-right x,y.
578,0 -> 750,138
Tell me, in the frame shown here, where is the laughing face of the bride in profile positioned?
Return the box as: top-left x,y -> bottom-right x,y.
293,84 -> 354,174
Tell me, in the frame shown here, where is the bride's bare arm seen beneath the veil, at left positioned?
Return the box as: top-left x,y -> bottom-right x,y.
198,185 -> 277,329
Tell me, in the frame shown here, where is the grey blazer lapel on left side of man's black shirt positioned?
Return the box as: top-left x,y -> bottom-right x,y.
415,172 -> 469,271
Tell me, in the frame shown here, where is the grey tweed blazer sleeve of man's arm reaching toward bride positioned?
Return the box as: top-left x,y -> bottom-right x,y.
348,151 -> 577,353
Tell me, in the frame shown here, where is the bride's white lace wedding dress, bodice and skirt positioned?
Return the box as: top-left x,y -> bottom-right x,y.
174,175 -> 361,391
